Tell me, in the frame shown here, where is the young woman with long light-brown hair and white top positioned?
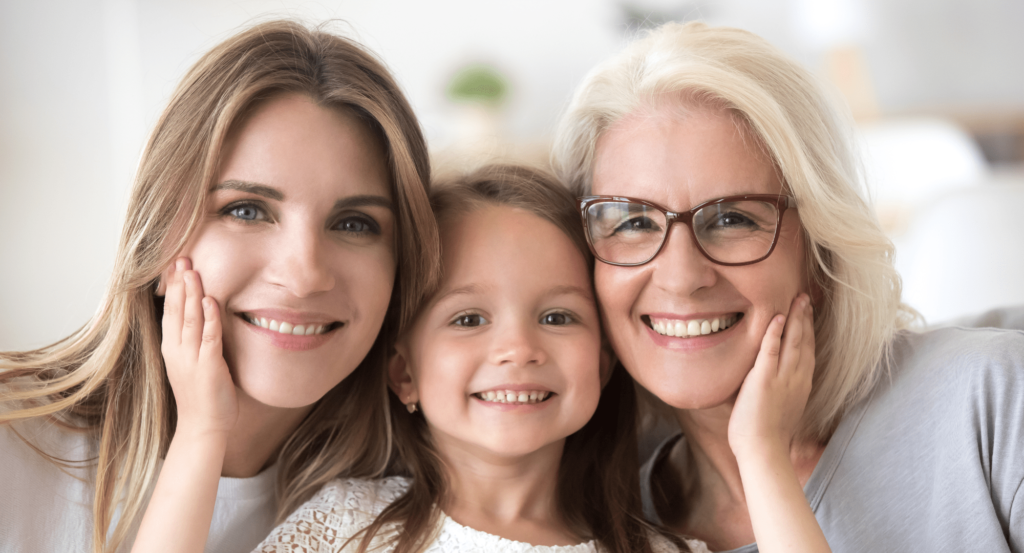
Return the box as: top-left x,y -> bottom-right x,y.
0,22 -> 438,553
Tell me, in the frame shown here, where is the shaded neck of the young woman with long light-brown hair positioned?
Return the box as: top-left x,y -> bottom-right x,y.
221,387 -> 312,478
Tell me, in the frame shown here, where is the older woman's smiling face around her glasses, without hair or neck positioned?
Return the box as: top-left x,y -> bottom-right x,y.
593,105 -> 807,409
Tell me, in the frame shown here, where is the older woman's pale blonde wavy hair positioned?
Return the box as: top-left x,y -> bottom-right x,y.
553,23 -> 914,442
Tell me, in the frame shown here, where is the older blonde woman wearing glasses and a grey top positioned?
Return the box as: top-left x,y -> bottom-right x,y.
555,24 -> 1024,552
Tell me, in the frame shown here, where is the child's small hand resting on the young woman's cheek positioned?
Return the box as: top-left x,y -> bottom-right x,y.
161,258 -> 239,437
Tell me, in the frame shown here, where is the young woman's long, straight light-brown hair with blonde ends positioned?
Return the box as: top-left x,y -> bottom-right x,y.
0,20 -> 439,552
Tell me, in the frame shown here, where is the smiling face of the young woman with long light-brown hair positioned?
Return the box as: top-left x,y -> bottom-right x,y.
172,94 -> 395,408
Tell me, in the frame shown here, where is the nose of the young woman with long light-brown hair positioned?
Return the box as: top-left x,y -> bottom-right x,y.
266,225 -> 335,298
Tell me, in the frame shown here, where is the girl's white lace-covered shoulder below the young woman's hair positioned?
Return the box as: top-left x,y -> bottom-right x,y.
256,476 -> 409,553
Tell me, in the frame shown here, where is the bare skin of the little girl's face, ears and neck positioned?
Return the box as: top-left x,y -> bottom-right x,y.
389,206 -> 607,545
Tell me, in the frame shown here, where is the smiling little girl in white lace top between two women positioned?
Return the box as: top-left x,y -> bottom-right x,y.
249,166 -> 828,553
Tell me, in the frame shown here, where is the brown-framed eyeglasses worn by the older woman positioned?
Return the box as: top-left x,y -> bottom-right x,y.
579,195 -> 797,266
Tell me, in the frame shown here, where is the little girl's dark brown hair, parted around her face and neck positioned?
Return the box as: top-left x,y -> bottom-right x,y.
357,165 -> 688,553
